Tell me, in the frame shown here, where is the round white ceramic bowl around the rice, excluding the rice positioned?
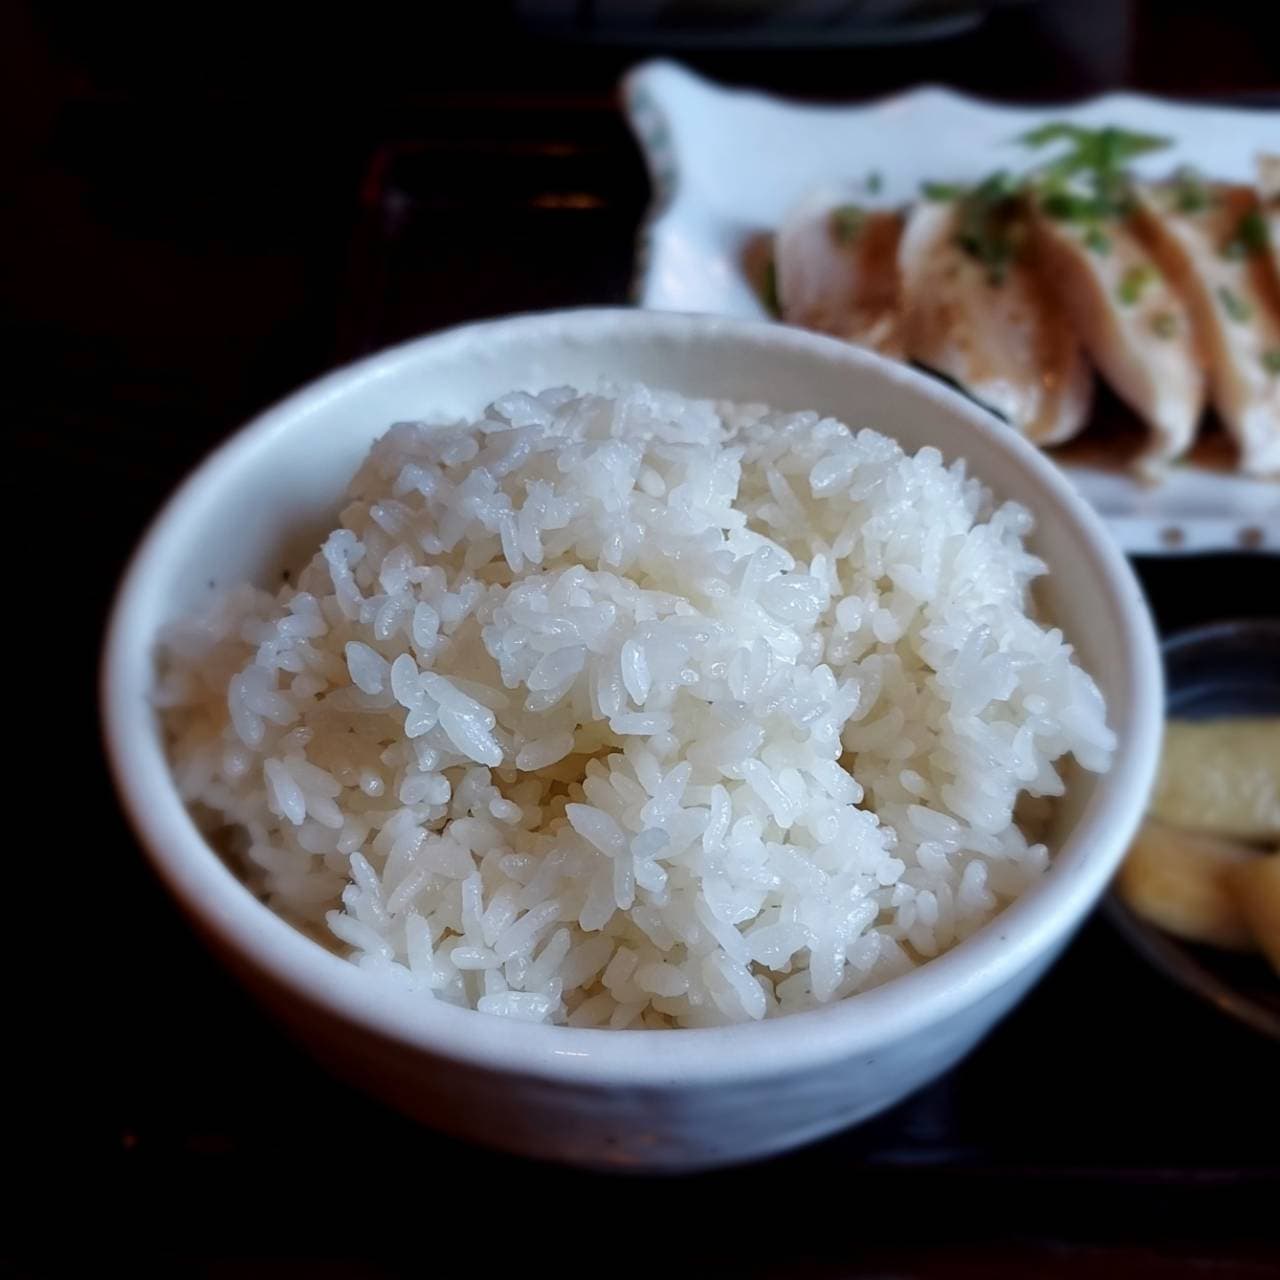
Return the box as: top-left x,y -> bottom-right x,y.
102,311 -> 1162,1170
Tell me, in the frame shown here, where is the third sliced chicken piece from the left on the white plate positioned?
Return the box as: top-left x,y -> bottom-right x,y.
1032,209 -> 1204,472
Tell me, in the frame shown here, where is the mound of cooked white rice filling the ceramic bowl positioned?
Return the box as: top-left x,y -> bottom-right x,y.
157,388 -> 1114,1028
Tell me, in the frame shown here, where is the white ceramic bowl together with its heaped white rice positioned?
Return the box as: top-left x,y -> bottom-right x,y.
102,311 -> 1161,1170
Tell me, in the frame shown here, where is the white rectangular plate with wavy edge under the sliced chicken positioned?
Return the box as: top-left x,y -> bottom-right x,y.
623,61 -> 1280,554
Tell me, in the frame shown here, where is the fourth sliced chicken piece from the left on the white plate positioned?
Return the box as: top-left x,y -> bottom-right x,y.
1138,183 -> 1280,476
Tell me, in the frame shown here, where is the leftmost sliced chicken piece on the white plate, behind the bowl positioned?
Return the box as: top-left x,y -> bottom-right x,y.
773,191 -> 902,357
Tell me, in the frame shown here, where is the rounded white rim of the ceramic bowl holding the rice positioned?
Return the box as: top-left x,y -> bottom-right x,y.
100,307 -> 1164,1087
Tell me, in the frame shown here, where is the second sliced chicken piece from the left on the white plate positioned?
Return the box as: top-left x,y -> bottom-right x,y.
897,201 -> 1093,444
